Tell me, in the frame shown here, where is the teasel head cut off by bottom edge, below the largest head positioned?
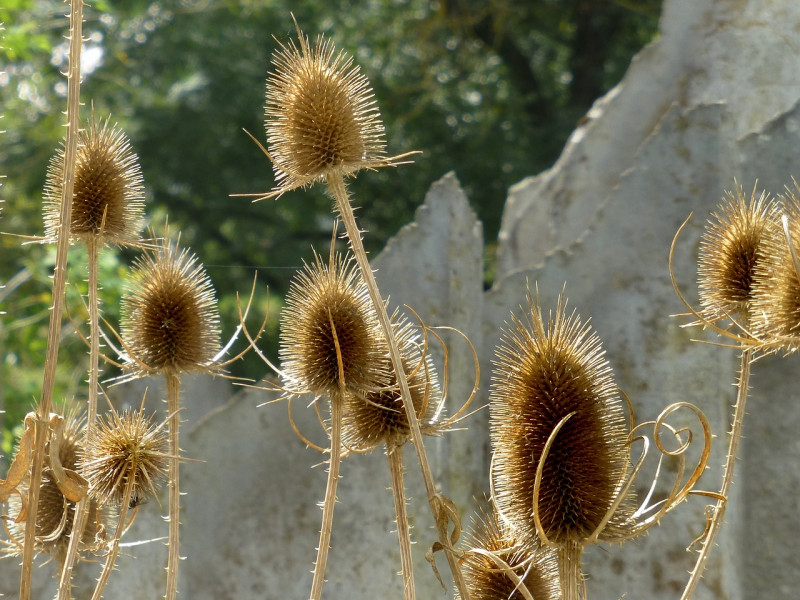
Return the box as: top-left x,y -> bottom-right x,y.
456,507 -> 560,600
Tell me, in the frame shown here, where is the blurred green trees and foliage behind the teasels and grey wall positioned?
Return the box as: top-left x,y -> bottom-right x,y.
0,0 -> 661,446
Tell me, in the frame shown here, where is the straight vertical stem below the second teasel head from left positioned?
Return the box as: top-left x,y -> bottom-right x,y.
166,371 -> 181,600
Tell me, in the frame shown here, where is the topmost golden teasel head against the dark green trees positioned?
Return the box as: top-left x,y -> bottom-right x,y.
262,17 -> 416,198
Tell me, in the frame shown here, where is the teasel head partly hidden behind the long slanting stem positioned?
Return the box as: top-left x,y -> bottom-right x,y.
342,313 -> 441,450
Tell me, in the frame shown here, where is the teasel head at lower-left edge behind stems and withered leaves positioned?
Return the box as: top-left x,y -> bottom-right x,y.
4,406 -> 110,563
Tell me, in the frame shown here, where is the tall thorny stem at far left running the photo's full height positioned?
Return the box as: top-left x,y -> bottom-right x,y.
19,0 -> 83,600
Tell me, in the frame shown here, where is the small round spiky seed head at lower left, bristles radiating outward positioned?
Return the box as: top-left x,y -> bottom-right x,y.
81,411 -> 169,509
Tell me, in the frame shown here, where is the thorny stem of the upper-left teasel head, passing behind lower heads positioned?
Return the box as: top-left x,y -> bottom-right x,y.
58,237 -> 100,600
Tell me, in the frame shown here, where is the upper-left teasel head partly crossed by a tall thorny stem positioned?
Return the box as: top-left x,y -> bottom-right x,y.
44,118 -> 144,244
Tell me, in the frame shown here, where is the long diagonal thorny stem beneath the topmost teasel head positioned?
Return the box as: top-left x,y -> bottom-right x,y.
325,172 -> 470,600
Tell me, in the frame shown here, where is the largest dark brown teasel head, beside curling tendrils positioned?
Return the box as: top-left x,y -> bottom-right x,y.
489,292 -> 632,545
